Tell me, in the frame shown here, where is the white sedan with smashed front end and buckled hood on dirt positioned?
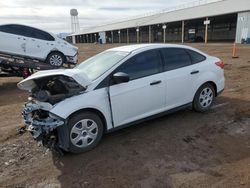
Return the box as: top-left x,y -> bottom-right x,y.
18,44 -> 224,153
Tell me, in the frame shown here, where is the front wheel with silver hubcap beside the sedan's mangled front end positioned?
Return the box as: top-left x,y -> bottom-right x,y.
68,112 -> 103,153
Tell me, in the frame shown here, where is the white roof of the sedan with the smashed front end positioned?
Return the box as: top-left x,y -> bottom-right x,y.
107,44 -> 192,52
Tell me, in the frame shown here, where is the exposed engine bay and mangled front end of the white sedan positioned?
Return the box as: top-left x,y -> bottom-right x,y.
22,75 -> 86,153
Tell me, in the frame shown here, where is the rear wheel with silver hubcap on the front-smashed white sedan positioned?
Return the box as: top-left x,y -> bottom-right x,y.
193,83 -> 215,112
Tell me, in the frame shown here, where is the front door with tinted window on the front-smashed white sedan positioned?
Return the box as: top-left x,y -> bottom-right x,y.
110,50 -> 166,126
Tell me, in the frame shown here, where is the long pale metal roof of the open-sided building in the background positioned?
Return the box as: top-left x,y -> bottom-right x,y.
72,0 -> 250,35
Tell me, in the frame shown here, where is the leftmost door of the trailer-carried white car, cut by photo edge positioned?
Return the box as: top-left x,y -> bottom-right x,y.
0,24 -> 27,56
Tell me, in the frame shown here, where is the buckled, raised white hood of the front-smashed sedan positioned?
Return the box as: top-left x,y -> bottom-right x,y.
17,68 -> 91,91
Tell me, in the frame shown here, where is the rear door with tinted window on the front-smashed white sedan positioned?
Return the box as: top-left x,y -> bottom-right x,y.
161,48 -> 200,109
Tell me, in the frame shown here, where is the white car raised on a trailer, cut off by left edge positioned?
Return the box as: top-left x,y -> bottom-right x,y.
0,24 -> 78,67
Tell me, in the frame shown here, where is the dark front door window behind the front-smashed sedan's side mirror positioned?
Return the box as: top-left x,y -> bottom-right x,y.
116,50 -> 161,80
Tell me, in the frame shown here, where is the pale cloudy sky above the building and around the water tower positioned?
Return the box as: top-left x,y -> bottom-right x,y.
0,0 -> 194,33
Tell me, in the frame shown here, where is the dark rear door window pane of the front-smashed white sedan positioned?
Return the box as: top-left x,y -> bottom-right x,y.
161,48 -> 192,71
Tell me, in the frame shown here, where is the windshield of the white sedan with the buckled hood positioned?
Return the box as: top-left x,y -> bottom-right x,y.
76,51 -> 129,81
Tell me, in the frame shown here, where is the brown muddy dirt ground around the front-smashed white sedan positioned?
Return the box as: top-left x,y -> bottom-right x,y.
0,44 -> 250,188
